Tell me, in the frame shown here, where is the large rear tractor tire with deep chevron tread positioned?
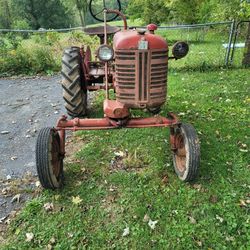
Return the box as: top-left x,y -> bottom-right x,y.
61,47 -> 87,117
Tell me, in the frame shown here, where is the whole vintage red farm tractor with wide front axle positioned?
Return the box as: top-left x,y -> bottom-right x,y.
36,0 -> 200,189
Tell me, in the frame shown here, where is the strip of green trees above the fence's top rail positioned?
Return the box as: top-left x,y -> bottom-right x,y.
0,0 -> 250,29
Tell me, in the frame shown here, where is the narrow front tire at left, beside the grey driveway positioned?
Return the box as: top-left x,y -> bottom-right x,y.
36,128 -> 64,190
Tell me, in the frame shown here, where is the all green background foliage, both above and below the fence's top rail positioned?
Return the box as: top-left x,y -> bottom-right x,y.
0,0 -> 250,76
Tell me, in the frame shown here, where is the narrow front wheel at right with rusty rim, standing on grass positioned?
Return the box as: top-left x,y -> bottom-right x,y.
172,124 -> 200,182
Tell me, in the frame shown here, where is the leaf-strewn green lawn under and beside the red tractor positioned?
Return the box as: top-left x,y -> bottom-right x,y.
1,69 -> 250,249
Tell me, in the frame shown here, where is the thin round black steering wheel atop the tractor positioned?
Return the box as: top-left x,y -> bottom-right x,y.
89,0 -> 122,22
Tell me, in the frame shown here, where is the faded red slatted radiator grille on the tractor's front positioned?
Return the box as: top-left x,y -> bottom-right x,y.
115,50 -> 168,108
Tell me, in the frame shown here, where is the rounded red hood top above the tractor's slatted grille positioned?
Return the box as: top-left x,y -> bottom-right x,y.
113,30 -> 168,50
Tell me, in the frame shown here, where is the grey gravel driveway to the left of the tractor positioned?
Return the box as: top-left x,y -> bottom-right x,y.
0,76 -> 66,179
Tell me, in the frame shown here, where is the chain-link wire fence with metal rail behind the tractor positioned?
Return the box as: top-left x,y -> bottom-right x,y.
0,21 -> 247,76
